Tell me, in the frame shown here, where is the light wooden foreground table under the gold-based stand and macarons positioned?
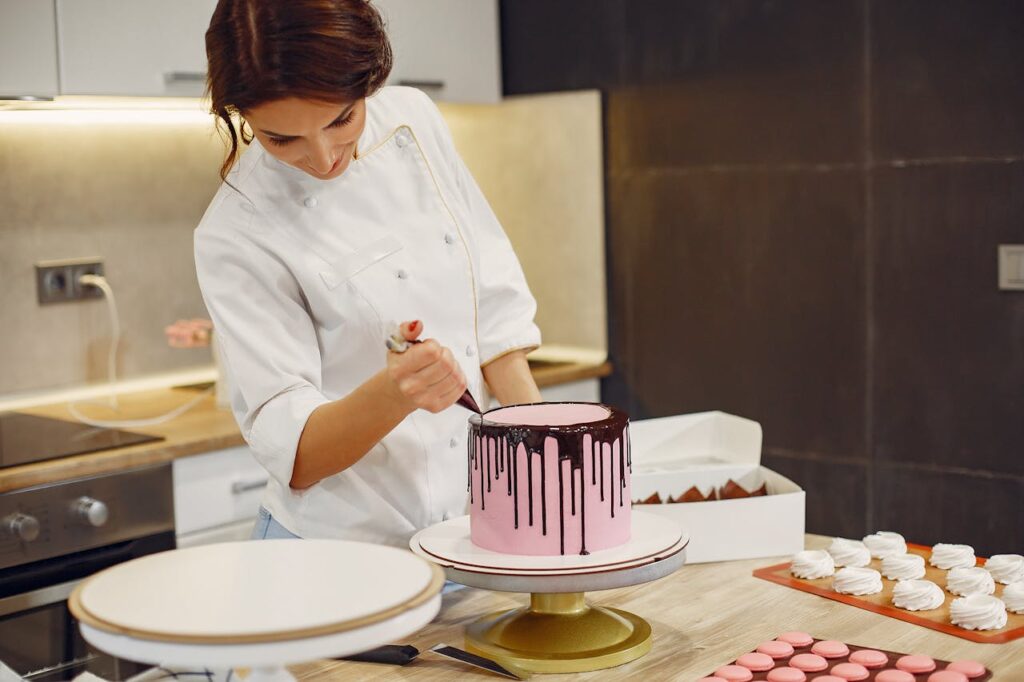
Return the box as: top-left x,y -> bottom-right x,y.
290,536 -> 1024,682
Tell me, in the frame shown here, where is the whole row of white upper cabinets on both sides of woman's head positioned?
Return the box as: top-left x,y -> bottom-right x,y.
0,0 -> 502,102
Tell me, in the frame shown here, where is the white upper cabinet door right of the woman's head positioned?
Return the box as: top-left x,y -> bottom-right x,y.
374,0 -> 502,102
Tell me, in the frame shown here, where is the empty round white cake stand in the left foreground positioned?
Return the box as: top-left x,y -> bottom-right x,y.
69,540 -> 444,681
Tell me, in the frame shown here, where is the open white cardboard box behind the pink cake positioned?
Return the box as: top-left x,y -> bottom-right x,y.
630,412 -> 804,563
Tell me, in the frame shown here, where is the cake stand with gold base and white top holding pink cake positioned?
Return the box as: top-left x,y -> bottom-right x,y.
410,511 -> 689,673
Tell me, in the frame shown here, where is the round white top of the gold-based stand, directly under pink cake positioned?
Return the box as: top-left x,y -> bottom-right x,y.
409,511 -> 689,593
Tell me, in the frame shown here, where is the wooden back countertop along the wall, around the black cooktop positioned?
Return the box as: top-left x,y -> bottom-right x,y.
0,360 -> 611,493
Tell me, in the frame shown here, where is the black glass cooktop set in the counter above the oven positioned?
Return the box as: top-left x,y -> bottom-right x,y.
0,412 -> 163,469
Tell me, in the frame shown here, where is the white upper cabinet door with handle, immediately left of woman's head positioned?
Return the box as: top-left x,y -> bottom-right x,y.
57,0 -> 217,96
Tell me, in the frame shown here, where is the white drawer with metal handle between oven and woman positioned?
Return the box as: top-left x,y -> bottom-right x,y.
173,445 -> 269,536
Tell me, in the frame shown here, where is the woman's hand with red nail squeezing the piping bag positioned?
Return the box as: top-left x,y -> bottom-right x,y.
387,321 -> 466,413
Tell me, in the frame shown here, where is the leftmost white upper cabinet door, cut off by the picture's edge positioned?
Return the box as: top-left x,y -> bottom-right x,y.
0,0 -> 57,97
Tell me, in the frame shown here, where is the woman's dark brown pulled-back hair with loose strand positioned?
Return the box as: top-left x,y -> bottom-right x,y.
206,0 -> 391,180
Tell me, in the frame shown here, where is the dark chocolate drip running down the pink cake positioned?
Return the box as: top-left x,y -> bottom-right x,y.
469,406 -> 633,554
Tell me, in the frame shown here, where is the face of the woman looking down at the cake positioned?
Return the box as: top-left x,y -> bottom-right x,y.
244,97 -> 367,180
